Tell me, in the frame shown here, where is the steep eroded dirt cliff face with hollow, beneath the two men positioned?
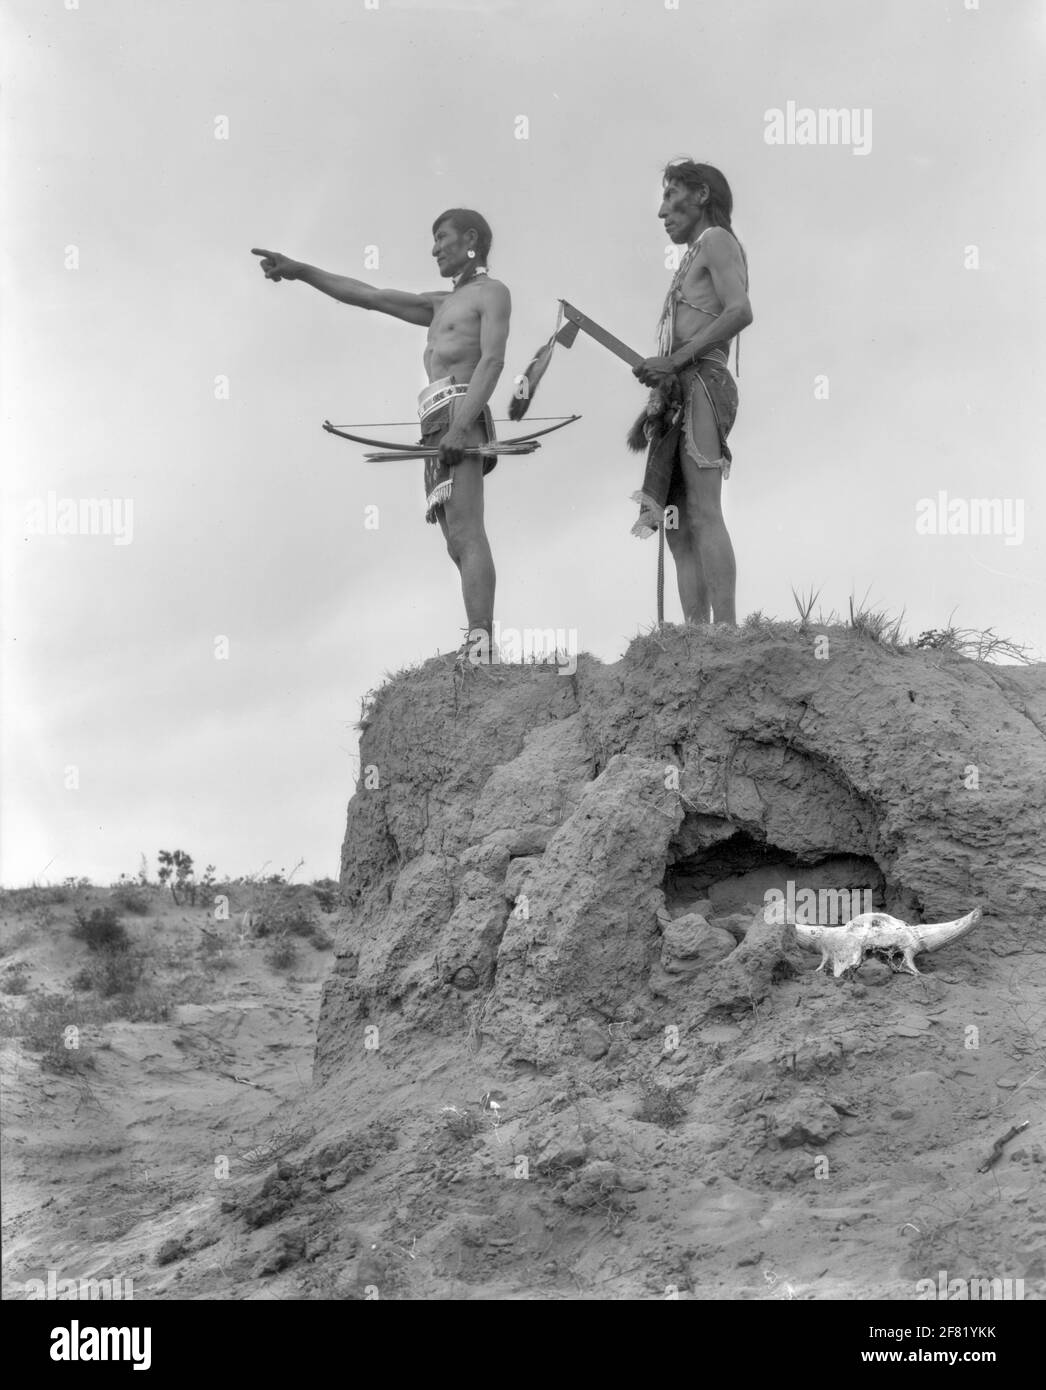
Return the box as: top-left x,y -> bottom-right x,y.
318,630 -> 1046,1073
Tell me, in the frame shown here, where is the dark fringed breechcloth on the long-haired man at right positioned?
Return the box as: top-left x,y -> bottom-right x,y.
629,354 -> 738,538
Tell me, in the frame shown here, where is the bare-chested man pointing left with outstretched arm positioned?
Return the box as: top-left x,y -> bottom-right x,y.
253,207 -> 511,649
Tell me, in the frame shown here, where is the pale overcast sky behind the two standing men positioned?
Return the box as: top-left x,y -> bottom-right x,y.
0,0 -> 1046,884
